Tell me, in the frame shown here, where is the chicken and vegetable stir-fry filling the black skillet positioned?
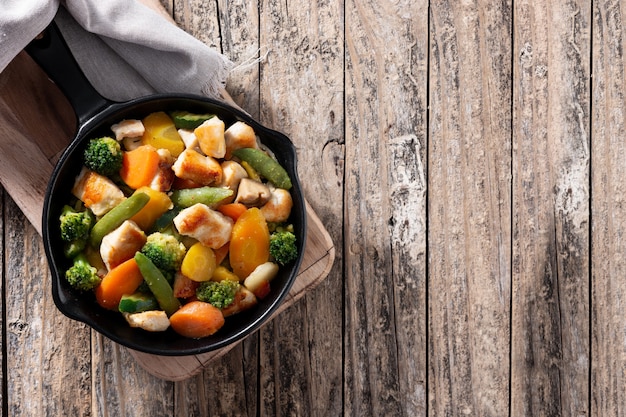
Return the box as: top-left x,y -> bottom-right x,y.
59,110 -> 298,338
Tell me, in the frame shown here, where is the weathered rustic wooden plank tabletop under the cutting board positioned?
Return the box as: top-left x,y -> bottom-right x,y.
0,0 -> 626,417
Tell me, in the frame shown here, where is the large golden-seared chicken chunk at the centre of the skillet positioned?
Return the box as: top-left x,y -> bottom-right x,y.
174,203 -> 233,249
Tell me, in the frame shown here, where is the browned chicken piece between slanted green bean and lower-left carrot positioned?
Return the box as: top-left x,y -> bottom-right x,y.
100,220 -> 146,271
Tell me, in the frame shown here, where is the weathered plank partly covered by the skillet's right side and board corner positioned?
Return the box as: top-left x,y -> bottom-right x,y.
258,0 -> 344,416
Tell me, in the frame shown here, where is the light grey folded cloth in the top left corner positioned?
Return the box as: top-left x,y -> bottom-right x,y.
0,0 -> 232,101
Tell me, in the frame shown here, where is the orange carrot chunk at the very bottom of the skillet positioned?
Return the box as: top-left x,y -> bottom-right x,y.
170,301 -> 225,339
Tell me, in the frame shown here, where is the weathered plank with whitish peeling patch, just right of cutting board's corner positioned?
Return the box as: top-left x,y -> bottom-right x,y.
344,1 -> 428,416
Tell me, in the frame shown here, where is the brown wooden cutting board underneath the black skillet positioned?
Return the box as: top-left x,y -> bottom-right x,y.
0,53 -> 335,381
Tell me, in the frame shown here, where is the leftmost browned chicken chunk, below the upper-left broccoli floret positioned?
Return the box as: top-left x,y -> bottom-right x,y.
72,167 -> 126,217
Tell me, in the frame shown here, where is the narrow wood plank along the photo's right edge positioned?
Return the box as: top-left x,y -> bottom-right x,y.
589,1 -> 626,416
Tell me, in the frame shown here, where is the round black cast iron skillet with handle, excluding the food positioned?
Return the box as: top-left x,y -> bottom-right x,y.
26,23 -> 306,356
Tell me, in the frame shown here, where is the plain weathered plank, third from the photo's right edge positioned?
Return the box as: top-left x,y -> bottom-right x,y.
428,1 -> 512,416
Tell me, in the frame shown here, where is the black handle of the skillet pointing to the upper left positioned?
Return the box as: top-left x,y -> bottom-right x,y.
24,21 -> 112,126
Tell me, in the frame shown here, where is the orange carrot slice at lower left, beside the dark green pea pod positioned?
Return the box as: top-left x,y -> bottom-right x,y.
95,258 -> 143,310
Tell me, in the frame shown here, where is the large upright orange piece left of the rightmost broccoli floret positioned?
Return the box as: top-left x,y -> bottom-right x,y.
229,207 -> 270,279
